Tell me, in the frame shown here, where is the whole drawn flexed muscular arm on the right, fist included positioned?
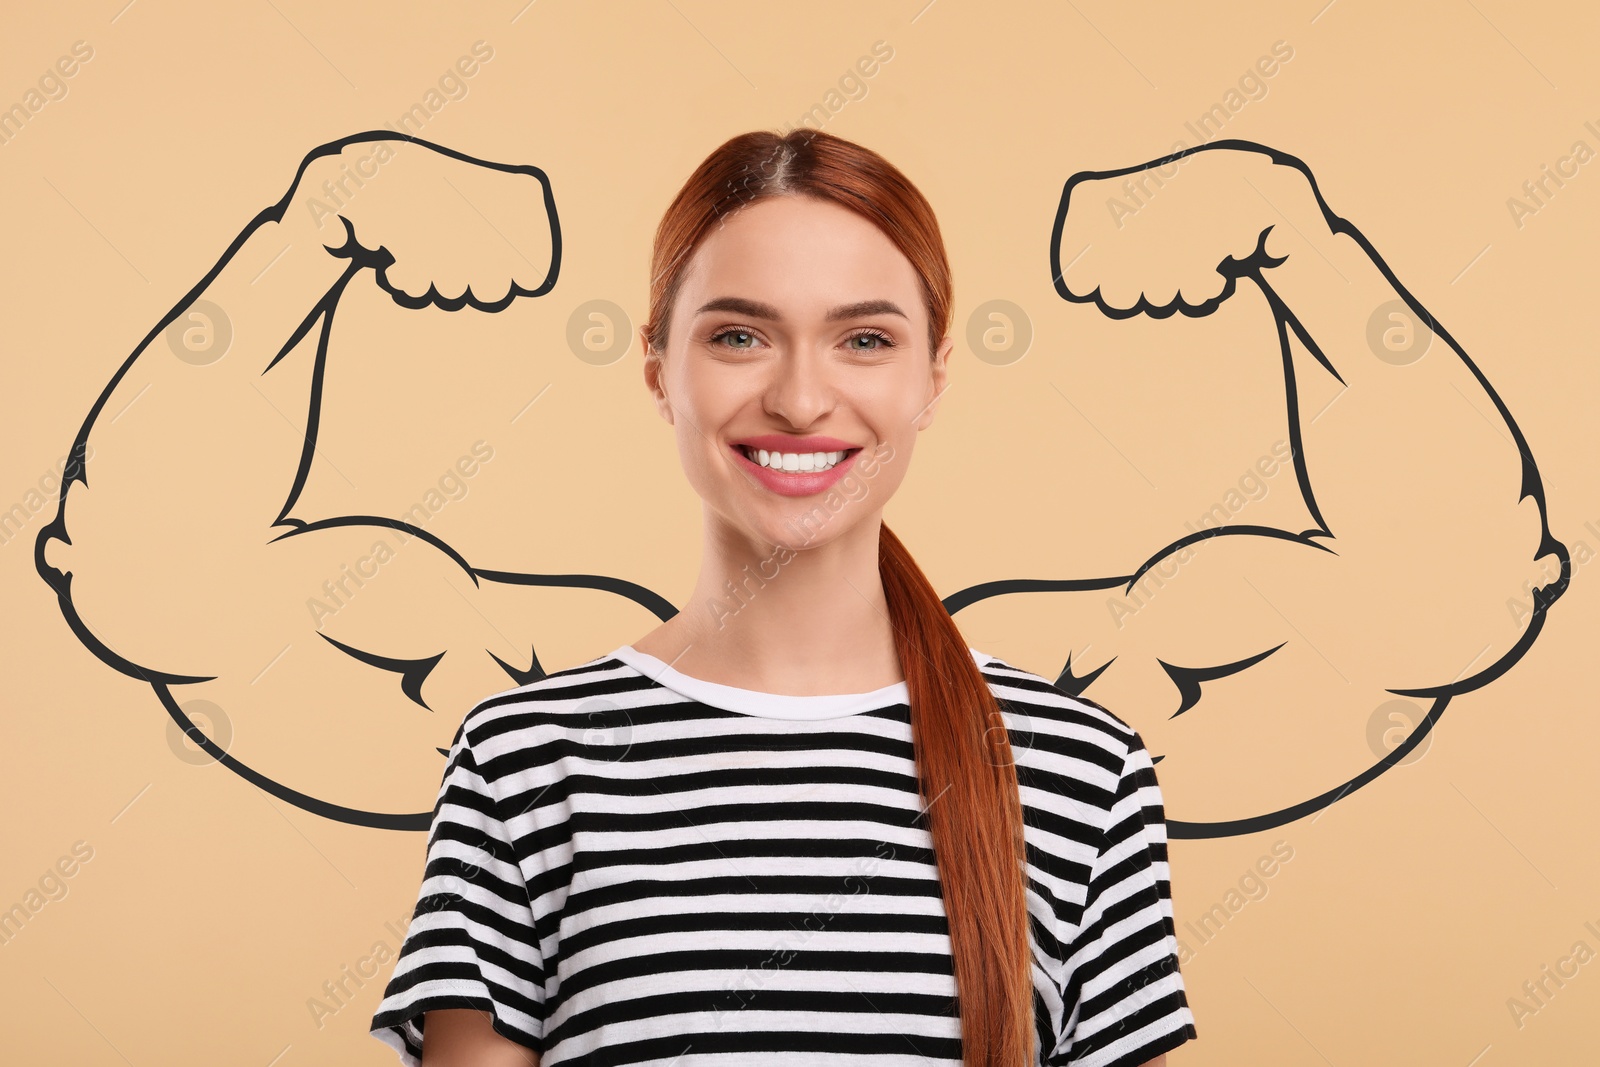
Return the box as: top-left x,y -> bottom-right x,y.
946,141 -> 1570,837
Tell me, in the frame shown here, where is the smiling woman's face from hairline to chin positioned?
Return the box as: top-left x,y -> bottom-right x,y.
645,197 -> 952,549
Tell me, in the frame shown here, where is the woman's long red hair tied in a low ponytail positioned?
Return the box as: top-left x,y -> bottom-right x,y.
643,128 -> 1035,1067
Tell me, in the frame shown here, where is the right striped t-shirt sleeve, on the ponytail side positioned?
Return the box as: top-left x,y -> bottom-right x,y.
1046,733 -> 1197,1067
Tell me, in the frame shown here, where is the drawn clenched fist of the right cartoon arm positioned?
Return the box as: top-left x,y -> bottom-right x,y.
1050,141 -> 1336,318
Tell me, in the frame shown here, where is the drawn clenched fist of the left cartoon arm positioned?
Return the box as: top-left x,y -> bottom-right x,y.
288,131 -> 560,310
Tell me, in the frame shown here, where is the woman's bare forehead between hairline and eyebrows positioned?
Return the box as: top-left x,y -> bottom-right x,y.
678,197 -> 926,322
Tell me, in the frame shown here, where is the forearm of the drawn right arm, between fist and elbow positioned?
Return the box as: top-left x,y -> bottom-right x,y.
1248,204 -> 1565,591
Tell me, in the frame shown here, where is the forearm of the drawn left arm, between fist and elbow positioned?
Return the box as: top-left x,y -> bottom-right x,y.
40,141 -> 360,681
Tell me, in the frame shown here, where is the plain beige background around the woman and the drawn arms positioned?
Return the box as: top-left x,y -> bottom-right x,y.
0,0 -> 1600,1067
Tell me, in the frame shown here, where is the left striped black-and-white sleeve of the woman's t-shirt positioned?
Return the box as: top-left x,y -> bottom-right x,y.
371,725 -> 544,1067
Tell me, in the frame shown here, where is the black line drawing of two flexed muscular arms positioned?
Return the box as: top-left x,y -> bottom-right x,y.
35,130 -> 1571,838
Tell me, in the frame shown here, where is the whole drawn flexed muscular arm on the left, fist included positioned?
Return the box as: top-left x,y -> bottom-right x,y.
35,131 -> 672,829
